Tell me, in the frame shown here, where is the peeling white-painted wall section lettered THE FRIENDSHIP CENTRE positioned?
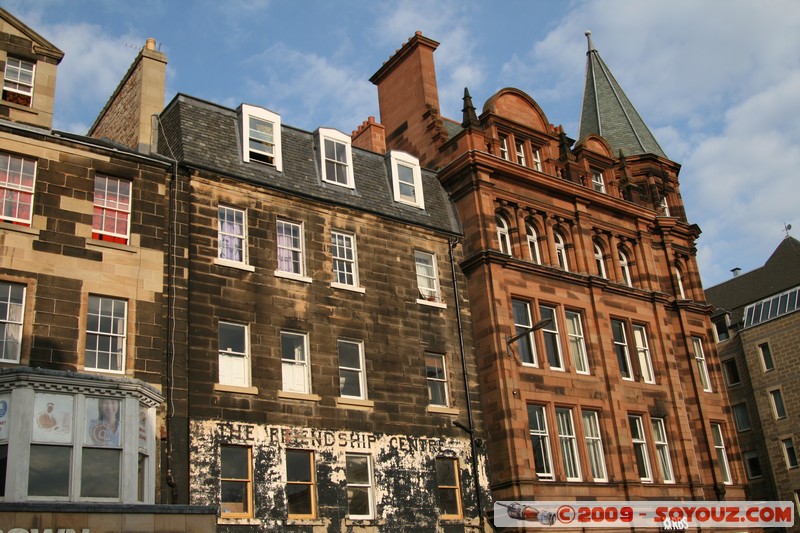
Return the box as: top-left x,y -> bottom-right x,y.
190,420 -> 488,532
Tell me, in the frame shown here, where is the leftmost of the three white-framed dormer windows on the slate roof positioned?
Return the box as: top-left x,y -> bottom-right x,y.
239,104 -> 283,171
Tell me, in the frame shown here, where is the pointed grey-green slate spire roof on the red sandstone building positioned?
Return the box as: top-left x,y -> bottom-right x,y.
579,32 -> 667,159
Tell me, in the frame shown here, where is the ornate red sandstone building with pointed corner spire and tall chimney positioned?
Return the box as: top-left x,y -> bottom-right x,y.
362,32 -> 745,512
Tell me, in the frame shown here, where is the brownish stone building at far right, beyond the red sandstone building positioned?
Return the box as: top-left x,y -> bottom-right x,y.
706,235 -> 800,520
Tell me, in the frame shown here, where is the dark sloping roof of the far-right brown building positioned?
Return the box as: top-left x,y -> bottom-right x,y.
705,237 -> 800,321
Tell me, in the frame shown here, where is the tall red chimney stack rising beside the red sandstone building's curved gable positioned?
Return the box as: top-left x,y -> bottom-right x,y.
369,31 -> 447,166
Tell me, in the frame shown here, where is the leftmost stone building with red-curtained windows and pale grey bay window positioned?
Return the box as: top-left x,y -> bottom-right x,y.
0,5 -> 214,533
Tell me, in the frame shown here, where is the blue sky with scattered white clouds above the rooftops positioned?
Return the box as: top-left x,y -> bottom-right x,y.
6,0 -> 800,288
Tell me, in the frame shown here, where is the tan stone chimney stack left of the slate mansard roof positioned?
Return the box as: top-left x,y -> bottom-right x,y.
89,38 -> 167,154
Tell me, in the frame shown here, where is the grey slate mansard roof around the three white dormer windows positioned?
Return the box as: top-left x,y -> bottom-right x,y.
158,94 -> 461,235
